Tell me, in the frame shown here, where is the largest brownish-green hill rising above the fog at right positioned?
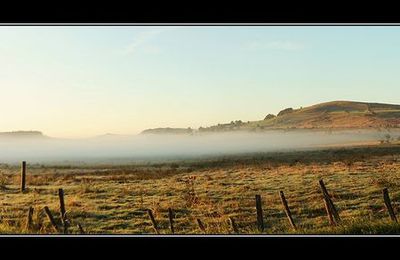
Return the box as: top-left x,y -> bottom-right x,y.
199,101 -> 400,132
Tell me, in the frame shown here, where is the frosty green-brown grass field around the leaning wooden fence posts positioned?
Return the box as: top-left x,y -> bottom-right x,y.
0,145 -> 400,234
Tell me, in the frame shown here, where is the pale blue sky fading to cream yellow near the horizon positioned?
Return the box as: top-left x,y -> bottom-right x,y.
0,26 -> 400,138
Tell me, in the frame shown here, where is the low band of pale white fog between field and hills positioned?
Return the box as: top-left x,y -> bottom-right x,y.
0,130 -> 400,163
